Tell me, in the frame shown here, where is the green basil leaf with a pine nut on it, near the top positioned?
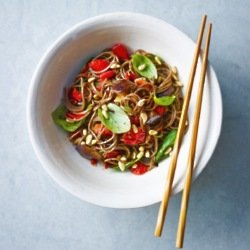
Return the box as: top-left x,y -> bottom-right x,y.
132,54 -> 157,80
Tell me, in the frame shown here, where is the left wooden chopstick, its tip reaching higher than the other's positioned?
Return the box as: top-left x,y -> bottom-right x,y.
155,15 -> 207,237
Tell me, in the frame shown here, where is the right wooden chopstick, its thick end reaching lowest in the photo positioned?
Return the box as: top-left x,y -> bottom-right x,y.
176,23 -> 212,248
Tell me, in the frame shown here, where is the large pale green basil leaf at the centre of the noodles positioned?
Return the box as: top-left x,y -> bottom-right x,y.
98,103 -> 131,134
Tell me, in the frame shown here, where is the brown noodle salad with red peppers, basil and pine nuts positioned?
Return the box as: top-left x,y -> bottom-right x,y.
52,43 -> 186,175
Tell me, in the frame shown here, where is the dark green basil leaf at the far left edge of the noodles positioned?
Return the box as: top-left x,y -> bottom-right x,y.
52,104 -> 85,132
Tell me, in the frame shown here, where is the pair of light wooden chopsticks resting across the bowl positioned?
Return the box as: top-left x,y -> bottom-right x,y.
155,15 -> 212,248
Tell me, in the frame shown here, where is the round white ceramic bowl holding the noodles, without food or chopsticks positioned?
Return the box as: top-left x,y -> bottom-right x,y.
27,13 -> 222,208
